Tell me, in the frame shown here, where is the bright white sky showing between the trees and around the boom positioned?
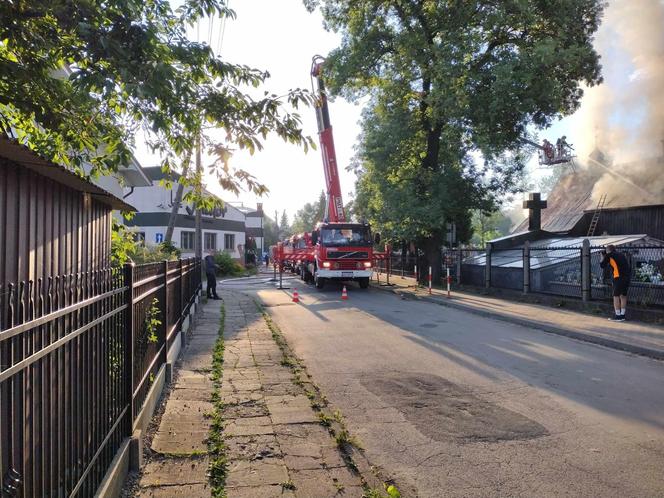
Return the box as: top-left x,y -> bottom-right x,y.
137,0 -> 657,221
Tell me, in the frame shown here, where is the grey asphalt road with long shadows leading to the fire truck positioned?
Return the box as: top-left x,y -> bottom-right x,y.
222,279 -> 664,497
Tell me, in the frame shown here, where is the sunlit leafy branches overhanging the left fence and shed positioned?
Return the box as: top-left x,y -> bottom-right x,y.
0,0 -> 313,199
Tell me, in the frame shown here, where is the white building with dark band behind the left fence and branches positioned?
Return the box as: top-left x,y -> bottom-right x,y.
126,167 -> 263,260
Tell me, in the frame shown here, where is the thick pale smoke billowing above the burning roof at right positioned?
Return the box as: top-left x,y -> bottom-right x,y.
573,0 -> 664,207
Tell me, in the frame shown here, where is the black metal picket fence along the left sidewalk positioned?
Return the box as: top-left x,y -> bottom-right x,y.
0,259 -> 201,497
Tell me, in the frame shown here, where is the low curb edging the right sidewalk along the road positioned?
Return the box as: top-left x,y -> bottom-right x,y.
371,284 -> 664,360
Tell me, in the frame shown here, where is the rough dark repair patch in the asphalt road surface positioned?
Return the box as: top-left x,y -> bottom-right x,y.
362,374 -> 548,443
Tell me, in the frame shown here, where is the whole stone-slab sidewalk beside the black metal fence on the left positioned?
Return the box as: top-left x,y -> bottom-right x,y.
136,291 -> 363,498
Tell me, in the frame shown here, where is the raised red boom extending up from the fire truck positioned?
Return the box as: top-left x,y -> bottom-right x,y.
311,55 -> 346,223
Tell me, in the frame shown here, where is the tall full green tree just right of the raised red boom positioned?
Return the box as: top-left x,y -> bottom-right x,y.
305,0 -> 603,279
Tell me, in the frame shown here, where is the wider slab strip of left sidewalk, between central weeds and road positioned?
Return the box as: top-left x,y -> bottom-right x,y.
221,292 -> 363,498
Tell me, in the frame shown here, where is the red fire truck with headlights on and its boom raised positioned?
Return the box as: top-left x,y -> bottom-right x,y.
272,56 -> 389,289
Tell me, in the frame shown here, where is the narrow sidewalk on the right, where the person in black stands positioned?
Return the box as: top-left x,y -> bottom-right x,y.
372,274 -> 664,360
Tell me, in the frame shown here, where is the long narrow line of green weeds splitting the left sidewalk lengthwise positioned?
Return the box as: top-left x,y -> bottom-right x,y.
208,303 -> 228,498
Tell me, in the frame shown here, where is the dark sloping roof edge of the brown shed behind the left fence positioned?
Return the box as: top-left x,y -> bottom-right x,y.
0,136 -> 136,211
